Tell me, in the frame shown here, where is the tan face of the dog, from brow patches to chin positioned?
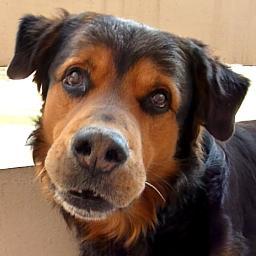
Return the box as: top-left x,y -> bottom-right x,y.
42,45 -> 181,219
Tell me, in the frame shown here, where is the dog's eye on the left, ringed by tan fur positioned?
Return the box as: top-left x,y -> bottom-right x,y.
62,68 -> 89,97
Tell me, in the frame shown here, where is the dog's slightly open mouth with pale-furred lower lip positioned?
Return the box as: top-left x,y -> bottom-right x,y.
54,189 -> 115,220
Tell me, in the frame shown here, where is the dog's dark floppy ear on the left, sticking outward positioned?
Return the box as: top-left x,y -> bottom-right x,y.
7,10 -> 68,99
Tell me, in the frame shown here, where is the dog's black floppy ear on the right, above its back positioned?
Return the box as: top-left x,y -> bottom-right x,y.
189,40 -> 249,140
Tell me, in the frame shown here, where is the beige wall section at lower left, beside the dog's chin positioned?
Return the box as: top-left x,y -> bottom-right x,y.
0,168 -> 78,256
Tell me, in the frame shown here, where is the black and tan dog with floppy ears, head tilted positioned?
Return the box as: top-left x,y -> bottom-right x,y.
7,11 -> 256,256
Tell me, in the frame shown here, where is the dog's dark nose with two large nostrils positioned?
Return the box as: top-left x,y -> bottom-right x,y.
72,127 -> 129,172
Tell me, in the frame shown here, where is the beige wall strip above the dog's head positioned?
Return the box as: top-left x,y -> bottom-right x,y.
0,0 -> 256,66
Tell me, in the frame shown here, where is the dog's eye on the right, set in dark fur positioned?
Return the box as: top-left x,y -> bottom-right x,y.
140,89 -> 170,114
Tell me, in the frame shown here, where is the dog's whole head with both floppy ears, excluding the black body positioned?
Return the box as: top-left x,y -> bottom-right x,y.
8,10 -> 248,244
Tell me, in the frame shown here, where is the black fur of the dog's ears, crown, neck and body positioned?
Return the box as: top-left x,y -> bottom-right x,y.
8,10 -> 256,256
